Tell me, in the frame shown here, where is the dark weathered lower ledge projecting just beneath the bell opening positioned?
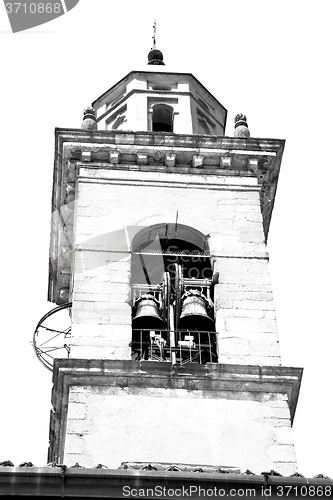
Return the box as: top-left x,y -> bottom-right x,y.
48,359 -> 302,462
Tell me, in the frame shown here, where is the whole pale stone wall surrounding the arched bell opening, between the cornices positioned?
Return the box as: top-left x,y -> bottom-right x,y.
71,166 -> 280,365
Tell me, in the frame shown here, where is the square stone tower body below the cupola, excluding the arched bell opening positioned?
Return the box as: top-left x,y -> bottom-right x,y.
49,129 -> 301,474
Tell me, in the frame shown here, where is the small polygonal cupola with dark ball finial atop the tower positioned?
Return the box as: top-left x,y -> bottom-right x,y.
92,69 -> 227,136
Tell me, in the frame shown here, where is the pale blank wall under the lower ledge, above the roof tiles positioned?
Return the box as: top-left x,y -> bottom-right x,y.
64,386 -> 296,475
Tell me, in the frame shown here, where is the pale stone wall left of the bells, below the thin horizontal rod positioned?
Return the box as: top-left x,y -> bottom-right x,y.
71,254 -> 132,359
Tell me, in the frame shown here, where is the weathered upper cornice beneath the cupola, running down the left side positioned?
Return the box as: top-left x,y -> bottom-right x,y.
48,129 -> 284,304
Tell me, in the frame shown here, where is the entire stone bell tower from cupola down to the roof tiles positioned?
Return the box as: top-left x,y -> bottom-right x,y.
35,46 -> 302,474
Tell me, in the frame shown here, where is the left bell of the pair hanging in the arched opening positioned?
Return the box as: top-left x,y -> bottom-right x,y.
132,294 -> 163,330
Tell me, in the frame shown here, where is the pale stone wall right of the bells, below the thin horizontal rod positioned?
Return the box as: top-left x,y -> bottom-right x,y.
215,258 -> 281,366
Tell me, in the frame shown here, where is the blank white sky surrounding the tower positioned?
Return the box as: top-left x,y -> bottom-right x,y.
0,0 -> 333,478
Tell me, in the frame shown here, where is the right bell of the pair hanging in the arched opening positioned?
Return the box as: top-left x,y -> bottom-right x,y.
179,290 -> 215,332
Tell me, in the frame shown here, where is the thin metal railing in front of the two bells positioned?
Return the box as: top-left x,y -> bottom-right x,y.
131,329 -> 218,365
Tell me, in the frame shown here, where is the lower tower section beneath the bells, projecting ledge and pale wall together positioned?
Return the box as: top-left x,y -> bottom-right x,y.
49,360 -> 299,475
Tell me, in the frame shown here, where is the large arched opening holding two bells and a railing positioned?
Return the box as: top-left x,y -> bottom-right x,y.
131,223 -> 217,364
